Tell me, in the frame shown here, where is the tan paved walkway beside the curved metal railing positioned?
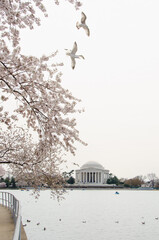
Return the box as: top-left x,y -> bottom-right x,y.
0,205 -> 27,240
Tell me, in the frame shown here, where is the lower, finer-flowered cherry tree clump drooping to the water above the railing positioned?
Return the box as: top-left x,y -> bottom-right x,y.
0,128 -> 67,197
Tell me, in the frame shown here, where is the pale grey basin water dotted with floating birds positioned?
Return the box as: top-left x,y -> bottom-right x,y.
4,189 -> 159,240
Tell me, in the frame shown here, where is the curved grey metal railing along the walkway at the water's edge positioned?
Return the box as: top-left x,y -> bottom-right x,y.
0,192 -> 21,240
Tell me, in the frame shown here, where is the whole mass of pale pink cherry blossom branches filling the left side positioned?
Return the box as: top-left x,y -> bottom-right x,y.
0,0 -> 86,196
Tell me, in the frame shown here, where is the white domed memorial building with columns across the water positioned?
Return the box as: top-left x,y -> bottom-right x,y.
75,161 -> 109,185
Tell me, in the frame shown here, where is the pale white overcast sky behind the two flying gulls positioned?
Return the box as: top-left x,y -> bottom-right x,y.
21,0 -> 159,177
